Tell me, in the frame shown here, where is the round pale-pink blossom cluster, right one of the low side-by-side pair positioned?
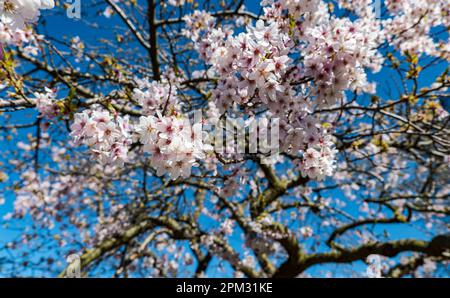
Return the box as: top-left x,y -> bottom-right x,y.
136,113 -> 210,179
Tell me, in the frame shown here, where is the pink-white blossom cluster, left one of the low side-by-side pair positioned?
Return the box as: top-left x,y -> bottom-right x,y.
70,110 -> 132,164
